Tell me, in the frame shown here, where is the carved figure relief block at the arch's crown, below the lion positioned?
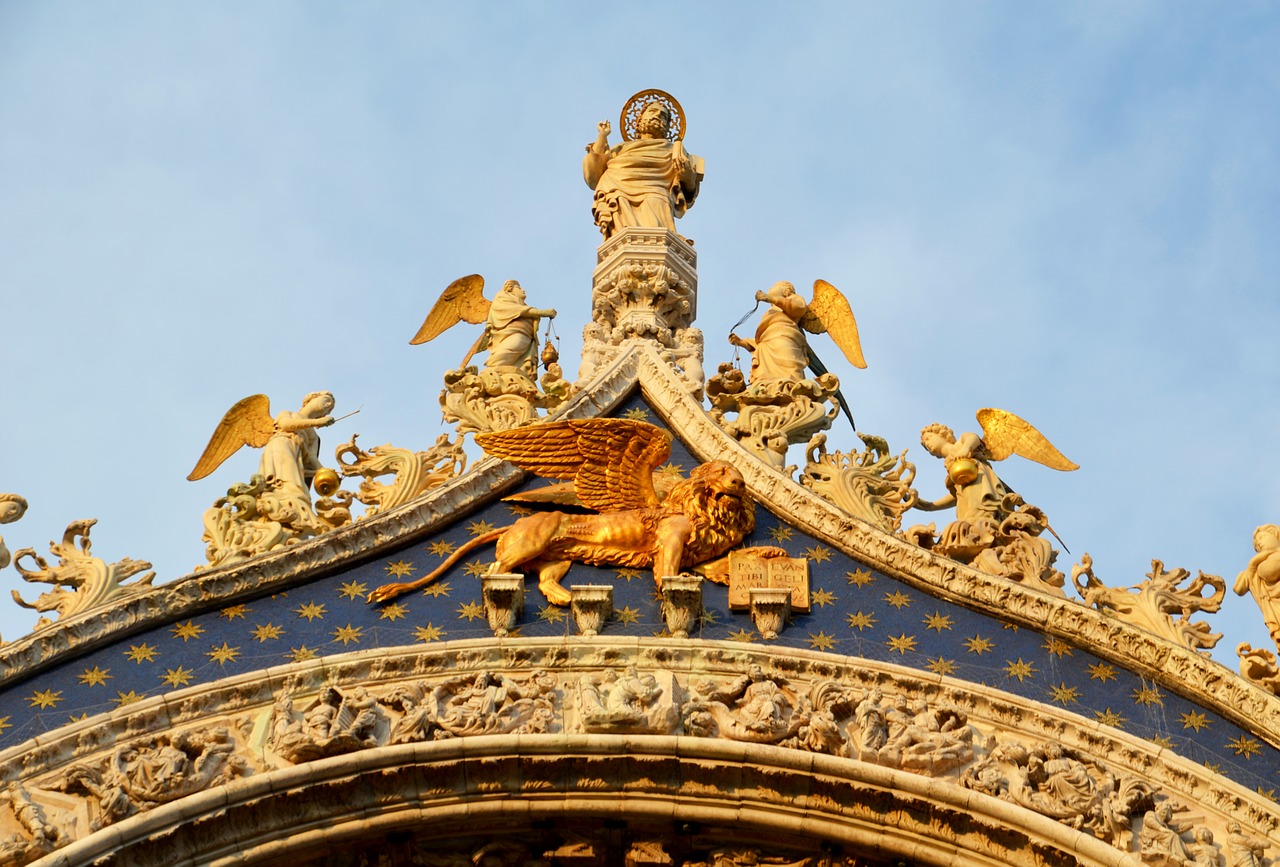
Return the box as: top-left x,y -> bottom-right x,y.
576,666 -> 680,734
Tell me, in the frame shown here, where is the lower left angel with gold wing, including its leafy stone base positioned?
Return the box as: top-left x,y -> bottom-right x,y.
187,392 -> 351,566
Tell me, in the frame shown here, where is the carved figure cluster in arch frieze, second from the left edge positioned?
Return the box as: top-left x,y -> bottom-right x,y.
58,727 -> 252,830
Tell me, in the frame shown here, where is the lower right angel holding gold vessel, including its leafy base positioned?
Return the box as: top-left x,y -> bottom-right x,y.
908,409 -> 1079,594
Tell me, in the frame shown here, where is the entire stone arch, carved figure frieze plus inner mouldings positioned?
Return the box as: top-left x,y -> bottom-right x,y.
0,638 -> 1280,867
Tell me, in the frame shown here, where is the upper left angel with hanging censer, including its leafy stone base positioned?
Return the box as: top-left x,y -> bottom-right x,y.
410,274 -> 566,433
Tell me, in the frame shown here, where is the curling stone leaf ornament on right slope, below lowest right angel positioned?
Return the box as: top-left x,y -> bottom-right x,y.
1071,553 -> 1226,652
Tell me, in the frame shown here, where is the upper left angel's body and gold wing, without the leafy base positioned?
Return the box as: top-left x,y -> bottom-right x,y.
410,274 -> 556,378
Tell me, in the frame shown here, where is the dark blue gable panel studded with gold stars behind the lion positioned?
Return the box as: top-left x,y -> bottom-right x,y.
0,398 -> 1280,797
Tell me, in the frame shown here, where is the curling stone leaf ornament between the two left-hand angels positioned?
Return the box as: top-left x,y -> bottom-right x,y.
334,434 -> 467,517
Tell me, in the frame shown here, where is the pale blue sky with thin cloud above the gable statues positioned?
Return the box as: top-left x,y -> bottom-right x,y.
0,1 -> 1280,668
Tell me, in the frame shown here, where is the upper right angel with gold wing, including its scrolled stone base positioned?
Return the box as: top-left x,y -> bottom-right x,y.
707,280 -> 867,469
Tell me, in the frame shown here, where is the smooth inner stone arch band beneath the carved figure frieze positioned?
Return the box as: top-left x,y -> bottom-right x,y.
35,735 -> 1138,867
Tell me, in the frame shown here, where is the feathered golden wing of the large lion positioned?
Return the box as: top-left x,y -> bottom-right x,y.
476,419 -> 671,512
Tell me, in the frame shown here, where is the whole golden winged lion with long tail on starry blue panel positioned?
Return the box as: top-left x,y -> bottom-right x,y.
369,419 -> 755,606
